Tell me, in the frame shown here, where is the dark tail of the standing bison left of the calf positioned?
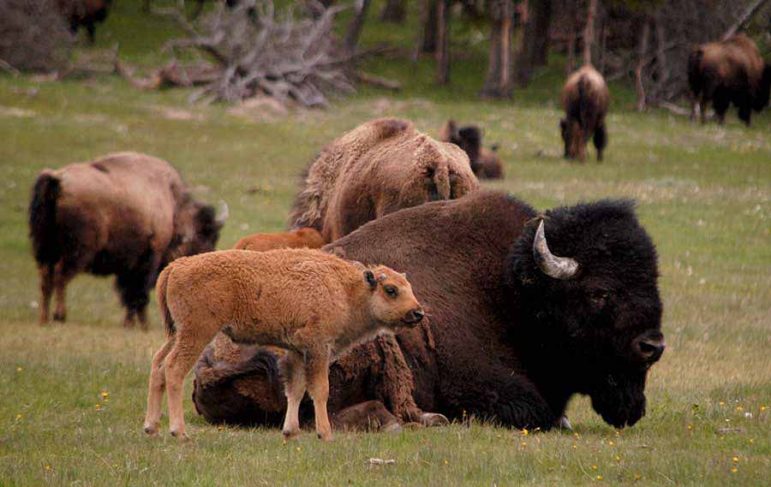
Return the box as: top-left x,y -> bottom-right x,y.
29,169 -> 62,266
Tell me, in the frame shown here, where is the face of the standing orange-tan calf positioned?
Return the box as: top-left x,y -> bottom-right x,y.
364,266 -> 425,327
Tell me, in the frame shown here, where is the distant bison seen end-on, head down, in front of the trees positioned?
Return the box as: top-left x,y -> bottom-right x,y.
560,64 -> 610,161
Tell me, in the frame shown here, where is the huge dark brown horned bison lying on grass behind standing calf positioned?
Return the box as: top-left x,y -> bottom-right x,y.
194,192 -> 664,429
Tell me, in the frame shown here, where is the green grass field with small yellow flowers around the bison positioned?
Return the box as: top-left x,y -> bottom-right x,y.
0,2 -> 771,486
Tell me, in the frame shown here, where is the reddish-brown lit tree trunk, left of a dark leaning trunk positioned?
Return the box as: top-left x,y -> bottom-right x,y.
481,0 -> 514,98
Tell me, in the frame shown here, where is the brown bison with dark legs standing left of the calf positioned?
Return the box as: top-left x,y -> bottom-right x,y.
29,152 -> 225,327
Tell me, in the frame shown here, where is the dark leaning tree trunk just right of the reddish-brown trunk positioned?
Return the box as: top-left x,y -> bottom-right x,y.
517,0 -> 551,86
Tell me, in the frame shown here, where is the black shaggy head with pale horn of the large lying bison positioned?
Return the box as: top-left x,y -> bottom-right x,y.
510,201 -> 664,427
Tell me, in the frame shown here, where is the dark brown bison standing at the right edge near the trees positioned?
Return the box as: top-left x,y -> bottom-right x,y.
688,34 -> 771,126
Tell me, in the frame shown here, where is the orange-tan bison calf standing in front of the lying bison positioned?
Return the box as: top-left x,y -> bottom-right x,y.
144,249 -> 423,440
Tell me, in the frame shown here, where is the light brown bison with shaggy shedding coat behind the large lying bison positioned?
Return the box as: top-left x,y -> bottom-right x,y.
290,118 -> 479,242
